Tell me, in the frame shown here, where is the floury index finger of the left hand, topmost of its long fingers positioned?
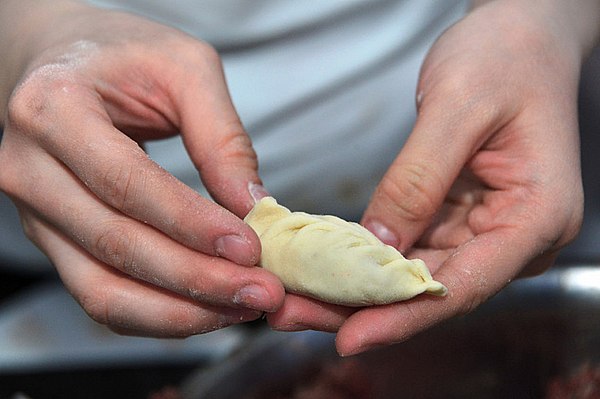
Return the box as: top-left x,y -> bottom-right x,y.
18,84 -> 260,265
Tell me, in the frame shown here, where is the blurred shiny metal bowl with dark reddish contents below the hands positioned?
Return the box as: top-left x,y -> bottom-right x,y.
181,265 -> 600,399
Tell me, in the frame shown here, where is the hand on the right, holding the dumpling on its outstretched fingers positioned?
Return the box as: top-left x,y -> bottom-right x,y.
268,1 -> 596,355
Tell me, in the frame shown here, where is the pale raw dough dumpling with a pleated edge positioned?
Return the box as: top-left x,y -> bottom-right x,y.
245,197 -> 447,306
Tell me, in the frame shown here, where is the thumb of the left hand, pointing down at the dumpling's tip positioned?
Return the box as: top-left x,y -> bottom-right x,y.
172,52 -> 261,217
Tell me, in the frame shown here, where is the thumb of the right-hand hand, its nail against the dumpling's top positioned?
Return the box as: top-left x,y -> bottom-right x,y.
361,92 -> 492,251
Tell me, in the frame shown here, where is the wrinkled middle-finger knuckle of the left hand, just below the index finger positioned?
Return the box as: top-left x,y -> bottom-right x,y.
93,222 -> 139,275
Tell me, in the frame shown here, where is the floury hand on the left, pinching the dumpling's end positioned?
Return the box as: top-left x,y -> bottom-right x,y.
0,0 -> 284,336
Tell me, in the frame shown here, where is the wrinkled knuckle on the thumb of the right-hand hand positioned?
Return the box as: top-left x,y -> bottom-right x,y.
378,164 -> 443,222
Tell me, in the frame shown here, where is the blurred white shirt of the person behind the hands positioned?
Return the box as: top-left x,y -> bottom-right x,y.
0,0 -> 467,267
